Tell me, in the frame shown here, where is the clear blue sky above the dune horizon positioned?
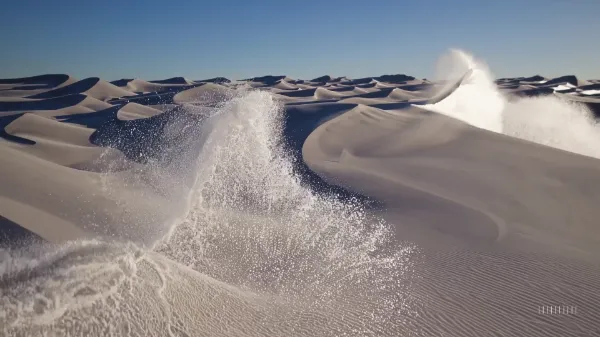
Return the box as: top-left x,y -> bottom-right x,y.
0,0 -> 600,80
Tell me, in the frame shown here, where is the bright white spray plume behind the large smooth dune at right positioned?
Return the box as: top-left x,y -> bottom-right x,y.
423,50 -> 600,158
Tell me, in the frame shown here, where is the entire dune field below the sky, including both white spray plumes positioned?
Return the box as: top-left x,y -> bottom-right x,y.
0,50 -> 600,337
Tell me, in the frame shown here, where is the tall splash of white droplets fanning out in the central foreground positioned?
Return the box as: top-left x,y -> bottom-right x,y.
158,92 -> 418,335
